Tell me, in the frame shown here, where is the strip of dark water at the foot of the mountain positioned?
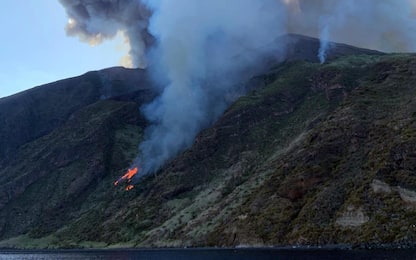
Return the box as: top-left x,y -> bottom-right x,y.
0,248 -> 416,260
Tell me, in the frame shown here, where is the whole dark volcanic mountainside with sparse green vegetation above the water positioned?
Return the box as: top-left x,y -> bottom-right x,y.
0,35 -> 416,248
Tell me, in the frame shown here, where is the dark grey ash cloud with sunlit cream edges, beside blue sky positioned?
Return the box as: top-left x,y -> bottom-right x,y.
59,0 -> 153,68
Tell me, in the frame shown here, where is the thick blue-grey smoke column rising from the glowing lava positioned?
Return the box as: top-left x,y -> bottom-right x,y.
139,0 -> 285,173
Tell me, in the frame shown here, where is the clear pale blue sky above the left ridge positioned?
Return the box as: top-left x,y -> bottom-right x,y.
0,0 -> 125,97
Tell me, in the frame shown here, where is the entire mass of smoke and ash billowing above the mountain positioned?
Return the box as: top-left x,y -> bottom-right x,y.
60,0 -> 416,177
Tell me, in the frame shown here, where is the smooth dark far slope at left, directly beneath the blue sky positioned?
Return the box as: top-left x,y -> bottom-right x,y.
0,67 -> 151,161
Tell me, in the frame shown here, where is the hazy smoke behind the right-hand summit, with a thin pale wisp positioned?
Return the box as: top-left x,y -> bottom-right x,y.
287,0 -> 416,62
